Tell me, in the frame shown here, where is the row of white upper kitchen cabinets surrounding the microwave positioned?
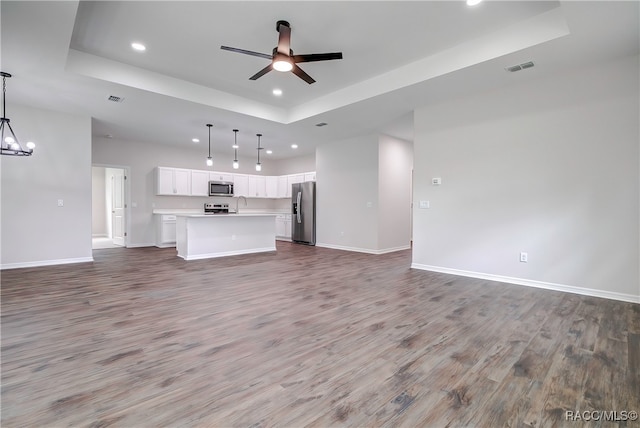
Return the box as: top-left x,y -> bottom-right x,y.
156,166 -> 316,199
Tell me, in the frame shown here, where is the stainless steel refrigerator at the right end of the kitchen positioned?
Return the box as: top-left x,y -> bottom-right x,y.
291,181 -> 316,245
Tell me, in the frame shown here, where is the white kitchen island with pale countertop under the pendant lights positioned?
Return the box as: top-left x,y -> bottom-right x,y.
176,214 -> 276,260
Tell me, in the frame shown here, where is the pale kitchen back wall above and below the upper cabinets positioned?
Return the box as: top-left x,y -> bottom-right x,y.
92,137 -> 289,247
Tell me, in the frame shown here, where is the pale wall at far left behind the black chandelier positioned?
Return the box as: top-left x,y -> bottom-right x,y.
0,105 -> 92,268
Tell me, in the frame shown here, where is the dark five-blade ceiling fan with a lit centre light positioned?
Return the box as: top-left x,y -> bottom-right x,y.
220,21 -> 342,84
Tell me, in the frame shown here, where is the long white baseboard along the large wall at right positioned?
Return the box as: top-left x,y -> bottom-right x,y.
411,263 -> 640,303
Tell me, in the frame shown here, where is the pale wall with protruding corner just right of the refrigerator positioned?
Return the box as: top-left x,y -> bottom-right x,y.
316,135 -> 413,254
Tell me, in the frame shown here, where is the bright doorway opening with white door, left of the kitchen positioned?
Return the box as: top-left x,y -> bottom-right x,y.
91,166 -> 127,250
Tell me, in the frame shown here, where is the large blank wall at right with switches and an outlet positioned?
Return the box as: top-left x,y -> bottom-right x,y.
413,56 -> 640,301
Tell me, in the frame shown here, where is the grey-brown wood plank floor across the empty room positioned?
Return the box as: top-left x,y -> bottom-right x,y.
1,242 -> 640,427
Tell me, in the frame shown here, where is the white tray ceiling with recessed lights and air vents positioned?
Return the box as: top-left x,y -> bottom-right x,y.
1,0 -> 639,158
